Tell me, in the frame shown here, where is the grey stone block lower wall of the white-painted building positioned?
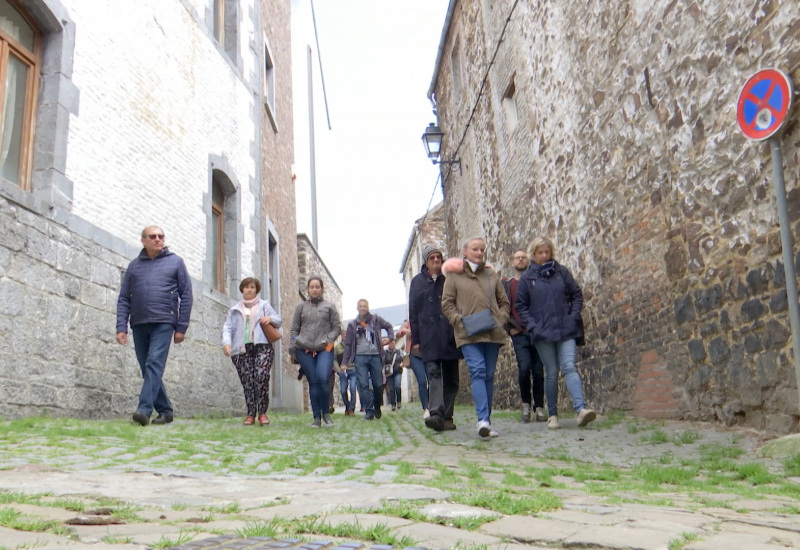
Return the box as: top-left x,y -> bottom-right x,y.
0,196 -> 244,418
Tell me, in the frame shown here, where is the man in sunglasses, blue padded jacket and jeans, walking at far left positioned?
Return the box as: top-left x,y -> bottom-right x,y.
117,226 -> 192,426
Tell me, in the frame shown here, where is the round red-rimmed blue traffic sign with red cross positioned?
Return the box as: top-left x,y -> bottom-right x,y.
736,69 -> 792,141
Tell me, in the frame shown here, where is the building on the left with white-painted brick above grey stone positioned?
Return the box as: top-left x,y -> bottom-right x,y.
0,0 -> 304,418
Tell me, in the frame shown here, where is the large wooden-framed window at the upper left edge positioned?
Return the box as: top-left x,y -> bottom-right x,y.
0,0 -> 40,189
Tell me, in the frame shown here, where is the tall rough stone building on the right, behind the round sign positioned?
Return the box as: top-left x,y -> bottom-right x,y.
429,0 -> 800,432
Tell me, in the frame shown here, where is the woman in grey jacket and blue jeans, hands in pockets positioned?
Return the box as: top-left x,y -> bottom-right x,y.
290,275 -> 342,428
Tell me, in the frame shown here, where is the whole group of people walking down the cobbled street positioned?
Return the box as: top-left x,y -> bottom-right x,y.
116,226 -> 596,437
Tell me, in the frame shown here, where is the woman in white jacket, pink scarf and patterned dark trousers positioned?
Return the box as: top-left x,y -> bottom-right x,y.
222,277 -> 281,426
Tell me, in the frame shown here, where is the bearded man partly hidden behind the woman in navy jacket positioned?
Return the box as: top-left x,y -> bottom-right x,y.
503,249 -> 547,422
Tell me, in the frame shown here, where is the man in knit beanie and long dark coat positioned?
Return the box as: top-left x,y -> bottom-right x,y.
408,244 -> 461,432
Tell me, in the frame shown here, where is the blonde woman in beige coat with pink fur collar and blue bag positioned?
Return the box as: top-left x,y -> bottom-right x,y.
442,237 -> 510,437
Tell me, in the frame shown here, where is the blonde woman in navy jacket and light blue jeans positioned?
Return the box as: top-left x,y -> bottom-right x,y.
515,237 -> 596,429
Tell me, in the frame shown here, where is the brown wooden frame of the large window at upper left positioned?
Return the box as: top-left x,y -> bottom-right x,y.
0,0 -> 42,191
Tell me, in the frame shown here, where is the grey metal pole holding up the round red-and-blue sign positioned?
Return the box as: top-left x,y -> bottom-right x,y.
769,136 -> 800,414
